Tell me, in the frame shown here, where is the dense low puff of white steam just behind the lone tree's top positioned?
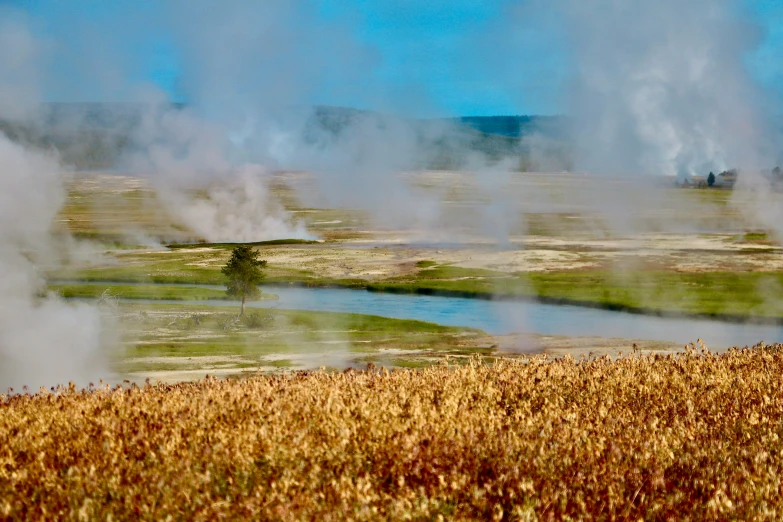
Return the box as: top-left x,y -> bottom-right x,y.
126,98 -> 309,242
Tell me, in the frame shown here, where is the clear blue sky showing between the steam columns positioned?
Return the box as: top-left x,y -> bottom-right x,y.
7,0 -> 783,116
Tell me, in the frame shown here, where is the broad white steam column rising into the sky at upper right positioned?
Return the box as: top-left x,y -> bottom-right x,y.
554,0 -> 771,178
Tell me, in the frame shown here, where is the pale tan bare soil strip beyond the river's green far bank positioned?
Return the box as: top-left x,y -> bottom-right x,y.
158,231 -> 783,281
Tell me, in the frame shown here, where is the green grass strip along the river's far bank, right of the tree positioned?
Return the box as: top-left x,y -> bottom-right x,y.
368,267 -> 783,320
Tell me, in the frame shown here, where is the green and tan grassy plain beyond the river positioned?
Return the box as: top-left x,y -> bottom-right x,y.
53,172 -> 783,368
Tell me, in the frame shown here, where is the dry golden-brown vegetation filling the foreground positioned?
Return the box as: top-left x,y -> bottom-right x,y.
0,345 -> 783,520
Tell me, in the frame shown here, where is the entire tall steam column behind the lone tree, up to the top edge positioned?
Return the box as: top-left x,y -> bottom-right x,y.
118,0 -> 370,242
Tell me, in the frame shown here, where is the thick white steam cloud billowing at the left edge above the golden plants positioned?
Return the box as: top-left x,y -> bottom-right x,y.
0,135 -> 108,391
